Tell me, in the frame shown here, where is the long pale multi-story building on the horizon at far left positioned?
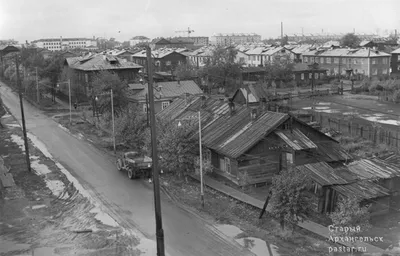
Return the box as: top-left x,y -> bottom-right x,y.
32,37 -> 97,51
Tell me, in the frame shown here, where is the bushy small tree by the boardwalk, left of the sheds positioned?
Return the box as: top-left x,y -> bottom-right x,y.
270,168 -> 313,230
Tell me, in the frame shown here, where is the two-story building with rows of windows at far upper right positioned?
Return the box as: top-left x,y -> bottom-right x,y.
303,48 -> 391,77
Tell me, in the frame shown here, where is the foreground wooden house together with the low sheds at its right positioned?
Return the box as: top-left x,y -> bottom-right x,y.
157,92 -> 400,215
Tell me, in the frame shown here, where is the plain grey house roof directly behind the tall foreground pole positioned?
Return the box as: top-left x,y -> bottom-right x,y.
133,80 -> 203,101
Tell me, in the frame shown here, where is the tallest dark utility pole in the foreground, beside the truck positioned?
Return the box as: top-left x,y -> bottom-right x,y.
146,46 -> 165,256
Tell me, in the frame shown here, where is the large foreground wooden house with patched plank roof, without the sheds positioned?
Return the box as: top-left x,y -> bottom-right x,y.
159,97 -> 351,186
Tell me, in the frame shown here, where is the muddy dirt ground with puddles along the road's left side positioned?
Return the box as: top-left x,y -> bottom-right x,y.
0,111 -> 139,256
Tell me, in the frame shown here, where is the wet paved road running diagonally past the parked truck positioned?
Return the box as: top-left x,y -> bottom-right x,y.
0,84 -> 253,256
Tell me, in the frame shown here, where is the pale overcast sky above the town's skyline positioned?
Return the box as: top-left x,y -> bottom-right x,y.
0,0 -> 400,43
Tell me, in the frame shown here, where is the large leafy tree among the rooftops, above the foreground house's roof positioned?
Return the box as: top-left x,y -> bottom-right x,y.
199,47 -> 242,91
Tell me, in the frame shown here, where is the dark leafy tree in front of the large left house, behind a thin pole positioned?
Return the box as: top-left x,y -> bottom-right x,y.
92,71 -> 129,117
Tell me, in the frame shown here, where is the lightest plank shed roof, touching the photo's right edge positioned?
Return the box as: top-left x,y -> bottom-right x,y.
347,158 -> 400,179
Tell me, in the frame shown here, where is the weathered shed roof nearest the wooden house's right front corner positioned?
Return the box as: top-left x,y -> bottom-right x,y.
296,162 -> 356,186
